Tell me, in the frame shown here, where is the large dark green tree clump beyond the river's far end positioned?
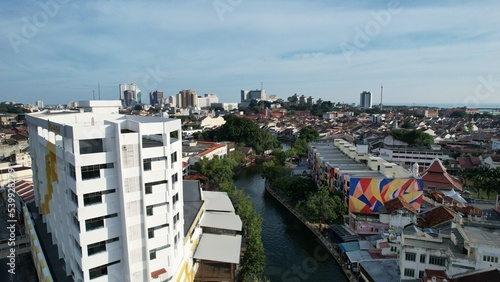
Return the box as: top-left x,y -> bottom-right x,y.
203,115 -> 279,153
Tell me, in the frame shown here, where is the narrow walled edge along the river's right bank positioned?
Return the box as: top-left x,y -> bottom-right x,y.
265,181 -> 358,282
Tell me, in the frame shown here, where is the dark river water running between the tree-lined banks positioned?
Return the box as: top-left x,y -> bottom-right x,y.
235,166 -> 348,282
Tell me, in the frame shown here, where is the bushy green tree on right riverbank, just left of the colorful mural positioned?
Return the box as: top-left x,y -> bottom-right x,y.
298,187 -> 344,222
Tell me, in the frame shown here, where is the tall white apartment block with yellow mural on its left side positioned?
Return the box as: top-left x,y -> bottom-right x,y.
27,101 -> 191,281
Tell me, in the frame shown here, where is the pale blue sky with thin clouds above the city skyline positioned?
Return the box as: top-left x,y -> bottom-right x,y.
0,0 -> 500,107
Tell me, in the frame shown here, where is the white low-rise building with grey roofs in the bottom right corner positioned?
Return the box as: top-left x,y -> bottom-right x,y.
399,223 -> 500,279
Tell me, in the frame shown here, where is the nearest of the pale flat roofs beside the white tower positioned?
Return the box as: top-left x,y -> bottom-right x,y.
193,233 -> 241,264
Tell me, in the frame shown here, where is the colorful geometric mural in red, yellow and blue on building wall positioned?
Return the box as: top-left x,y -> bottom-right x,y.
349,178 -> 424,213
